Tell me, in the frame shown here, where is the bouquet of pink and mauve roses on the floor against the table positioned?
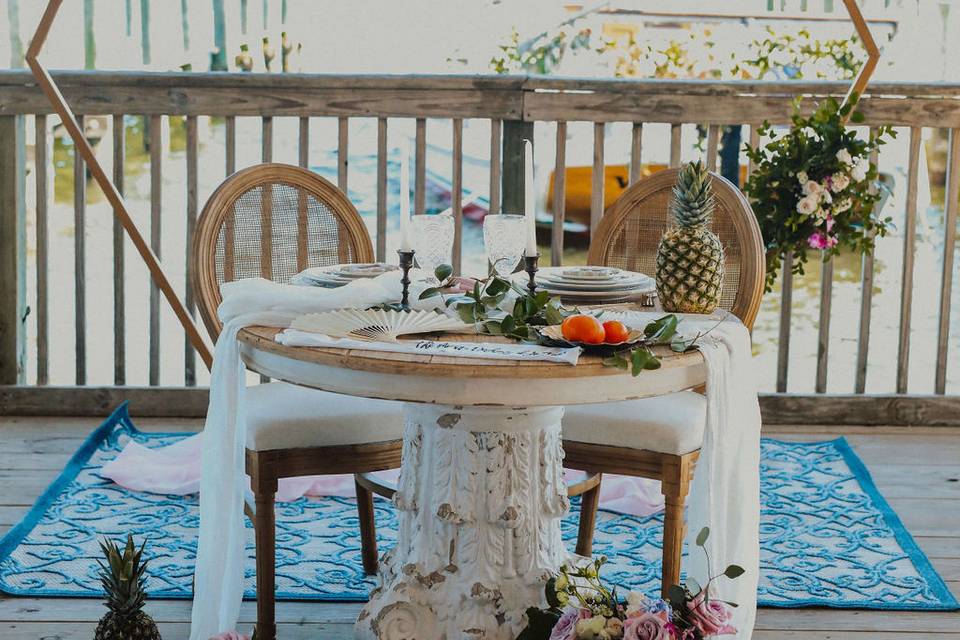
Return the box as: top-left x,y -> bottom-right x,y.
517,527 -> 743,640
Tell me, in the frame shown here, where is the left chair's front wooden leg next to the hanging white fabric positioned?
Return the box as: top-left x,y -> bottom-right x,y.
251,460 -> 277,640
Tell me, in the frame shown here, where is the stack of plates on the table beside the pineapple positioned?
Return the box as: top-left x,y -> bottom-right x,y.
521,267 -> 656,304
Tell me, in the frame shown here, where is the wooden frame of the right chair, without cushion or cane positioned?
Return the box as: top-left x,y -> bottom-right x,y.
563,169 -> 766,597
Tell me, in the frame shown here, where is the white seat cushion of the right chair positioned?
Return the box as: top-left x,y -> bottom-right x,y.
563,391 -> 707,455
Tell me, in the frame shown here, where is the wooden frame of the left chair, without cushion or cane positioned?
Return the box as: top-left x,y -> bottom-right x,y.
191,163 -> 402,640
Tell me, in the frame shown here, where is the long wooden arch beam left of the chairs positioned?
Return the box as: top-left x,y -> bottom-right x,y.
24,0 -> 213,369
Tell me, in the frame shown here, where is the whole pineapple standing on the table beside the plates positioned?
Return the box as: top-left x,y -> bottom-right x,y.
656,160 -> 724,313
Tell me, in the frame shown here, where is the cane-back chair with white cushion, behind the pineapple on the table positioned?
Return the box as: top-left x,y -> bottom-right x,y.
563,169 -> 765,596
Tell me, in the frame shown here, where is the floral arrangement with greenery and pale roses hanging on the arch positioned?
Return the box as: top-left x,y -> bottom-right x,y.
744,96 -> 896,291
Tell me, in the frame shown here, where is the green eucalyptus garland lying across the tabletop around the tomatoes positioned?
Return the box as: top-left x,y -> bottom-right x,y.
420,265 -> 707,376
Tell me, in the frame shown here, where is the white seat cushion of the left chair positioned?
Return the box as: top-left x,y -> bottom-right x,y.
247,382 -> 403,451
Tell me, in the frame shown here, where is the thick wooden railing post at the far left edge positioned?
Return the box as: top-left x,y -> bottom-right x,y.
0,115 -> 27,384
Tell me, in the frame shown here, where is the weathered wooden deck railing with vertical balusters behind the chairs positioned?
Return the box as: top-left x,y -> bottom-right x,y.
0,71 -> 960,424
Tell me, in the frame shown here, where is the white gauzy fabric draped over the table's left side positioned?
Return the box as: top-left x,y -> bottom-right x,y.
190,273 -> 434,640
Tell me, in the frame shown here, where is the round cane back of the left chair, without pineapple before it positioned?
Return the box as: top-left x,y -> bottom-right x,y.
192,163 -> 374,340
